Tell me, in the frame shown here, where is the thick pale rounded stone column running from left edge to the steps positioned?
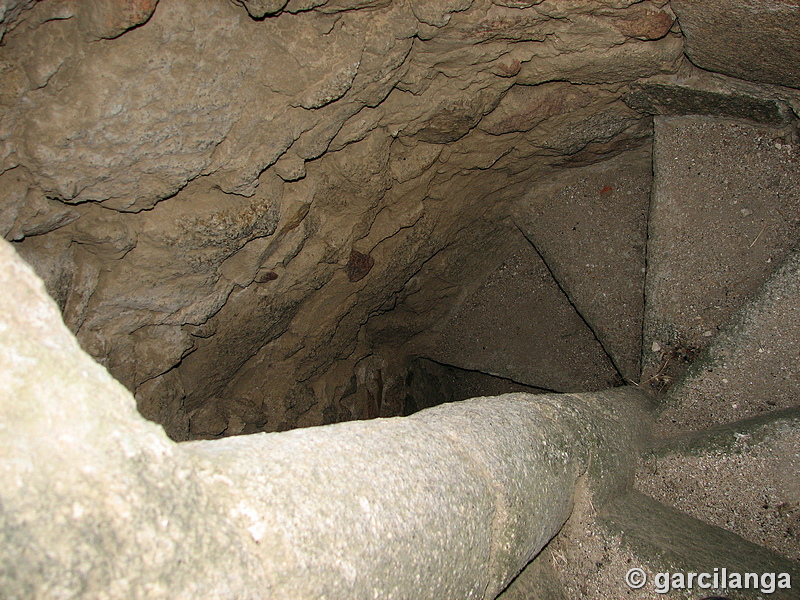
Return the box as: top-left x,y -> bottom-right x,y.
0,237 -> 642,600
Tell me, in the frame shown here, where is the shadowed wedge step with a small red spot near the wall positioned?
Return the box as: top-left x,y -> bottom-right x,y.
514,144 -> 652,381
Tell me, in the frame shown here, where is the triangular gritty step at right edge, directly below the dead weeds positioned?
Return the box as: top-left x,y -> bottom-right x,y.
657,246 -> 800,435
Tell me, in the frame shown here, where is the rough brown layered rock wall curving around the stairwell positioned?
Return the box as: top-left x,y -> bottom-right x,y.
0,0 -> 683,440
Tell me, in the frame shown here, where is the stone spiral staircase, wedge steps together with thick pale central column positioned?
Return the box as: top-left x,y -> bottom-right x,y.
0,115 -> 800,600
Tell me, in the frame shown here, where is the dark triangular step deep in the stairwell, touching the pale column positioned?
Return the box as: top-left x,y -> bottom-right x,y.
429,236 -> 622,392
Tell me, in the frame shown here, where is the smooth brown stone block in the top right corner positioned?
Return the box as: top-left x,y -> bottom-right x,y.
670,0 -> 800,87
